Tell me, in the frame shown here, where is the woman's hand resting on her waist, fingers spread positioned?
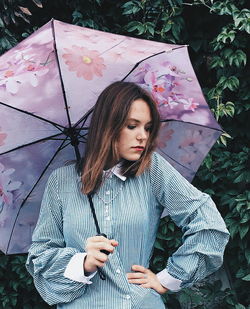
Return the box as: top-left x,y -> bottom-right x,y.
127,265 -> 168,294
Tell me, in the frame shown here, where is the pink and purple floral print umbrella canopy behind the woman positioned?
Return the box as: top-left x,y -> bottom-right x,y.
0,20 -> 221,254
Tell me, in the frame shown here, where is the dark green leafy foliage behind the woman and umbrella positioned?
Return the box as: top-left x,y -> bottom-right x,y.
0,0 -> 250,309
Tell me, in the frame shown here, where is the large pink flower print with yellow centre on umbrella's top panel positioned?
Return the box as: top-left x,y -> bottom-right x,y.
62,46 -> 106,80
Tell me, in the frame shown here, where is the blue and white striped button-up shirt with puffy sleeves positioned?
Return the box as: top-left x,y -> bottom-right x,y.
26,153 -> 229,309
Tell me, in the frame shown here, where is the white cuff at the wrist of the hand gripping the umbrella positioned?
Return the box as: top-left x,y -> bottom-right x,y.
63,253 -> 96,284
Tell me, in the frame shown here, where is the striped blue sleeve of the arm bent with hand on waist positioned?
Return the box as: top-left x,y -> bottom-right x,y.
151,154 -> 229,288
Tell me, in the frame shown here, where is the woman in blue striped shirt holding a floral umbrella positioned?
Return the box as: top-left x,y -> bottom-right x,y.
27,82 -> 228,309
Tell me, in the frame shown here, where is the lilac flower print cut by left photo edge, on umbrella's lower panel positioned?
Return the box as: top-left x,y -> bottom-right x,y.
0,163 -> 22,213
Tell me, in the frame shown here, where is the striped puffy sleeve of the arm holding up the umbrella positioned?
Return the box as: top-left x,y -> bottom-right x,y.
26,171 -> 87,305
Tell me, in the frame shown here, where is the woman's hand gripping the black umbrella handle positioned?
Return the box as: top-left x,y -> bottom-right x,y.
83,236 -> 118,273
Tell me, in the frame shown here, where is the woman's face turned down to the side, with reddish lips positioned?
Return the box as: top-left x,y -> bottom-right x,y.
117,99 -> 152,161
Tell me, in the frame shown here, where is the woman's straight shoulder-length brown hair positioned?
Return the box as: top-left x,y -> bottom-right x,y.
80,82 -> 160,194
